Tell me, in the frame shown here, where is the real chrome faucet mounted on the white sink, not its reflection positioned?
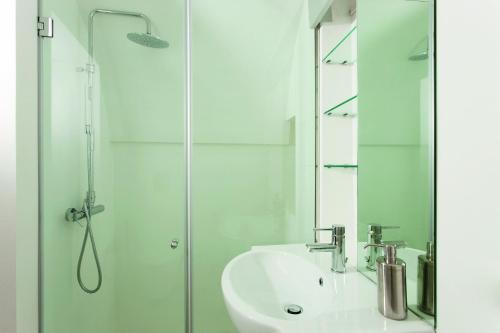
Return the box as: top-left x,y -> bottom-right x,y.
306,225 -> 347,273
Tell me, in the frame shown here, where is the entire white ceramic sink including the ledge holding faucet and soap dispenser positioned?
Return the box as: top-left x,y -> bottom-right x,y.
222,244 -> 433,333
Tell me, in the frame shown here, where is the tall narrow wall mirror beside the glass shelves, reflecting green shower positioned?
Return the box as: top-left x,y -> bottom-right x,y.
357,0 -> 435,322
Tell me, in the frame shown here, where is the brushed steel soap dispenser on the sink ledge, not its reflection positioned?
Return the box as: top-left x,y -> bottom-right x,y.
365,244 -> 408,320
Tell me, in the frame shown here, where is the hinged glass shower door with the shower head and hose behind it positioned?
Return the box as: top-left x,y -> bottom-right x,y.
40,0 -> 186,333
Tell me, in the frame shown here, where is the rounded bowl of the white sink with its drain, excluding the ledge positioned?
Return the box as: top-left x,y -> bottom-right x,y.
222,250 -> 333,333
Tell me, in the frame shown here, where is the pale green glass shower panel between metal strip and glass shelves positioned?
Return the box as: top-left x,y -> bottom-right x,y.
192,0 -> 314,333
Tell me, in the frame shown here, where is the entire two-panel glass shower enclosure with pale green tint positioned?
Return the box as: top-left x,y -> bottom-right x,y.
40,0 -> 315,333
